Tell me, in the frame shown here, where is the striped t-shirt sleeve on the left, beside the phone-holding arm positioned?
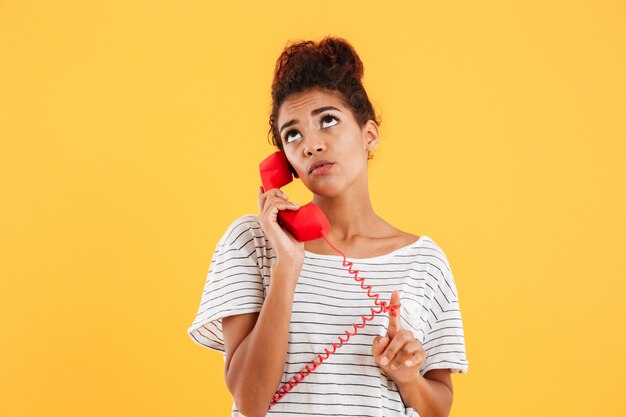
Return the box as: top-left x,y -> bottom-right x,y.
187,215 -> 265,353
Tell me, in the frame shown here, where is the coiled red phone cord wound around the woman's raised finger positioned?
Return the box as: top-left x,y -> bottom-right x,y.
267,230 -> 400,410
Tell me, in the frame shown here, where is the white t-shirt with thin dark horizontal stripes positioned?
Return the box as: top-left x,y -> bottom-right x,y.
188,214 -> 468,417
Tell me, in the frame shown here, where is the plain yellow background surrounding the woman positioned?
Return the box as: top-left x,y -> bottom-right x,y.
0,0 -> 626,417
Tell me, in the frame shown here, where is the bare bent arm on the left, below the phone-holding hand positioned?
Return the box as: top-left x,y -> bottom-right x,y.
222,262 -> 300,417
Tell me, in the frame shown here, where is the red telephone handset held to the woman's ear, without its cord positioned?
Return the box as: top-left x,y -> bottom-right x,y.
259,151 -> 330,242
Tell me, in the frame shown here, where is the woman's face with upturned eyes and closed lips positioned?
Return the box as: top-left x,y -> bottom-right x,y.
277,89 -> 379,197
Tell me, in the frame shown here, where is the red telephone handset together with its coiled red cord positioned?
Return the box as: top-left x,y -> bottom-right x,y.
259,151 -> 400,410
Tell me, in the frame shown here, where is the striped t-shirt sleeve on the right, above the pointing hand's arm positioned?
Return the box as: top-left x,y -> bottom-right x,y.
420,245 -> 469,376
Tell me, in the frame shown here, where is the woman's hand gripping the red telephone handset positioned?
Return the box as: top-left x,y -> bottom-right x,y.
258,186 -> 304,272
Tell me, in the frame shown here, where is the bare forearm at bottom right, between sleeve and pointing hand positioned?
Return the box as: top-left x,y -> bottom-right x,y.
397,374 -> 452,417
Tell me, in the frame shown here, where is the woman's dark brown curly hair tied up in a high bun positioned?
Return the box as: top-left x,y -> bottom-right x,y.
268,36 -> 381,160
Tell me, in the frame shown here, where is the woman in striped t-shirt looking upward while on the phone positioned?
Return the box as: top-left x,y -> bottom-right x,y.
188,37 -> 468,417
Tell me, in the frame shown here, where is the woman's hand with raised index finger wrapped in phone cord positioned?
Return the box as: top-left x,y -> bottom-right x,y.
372,290 -> 426,384
